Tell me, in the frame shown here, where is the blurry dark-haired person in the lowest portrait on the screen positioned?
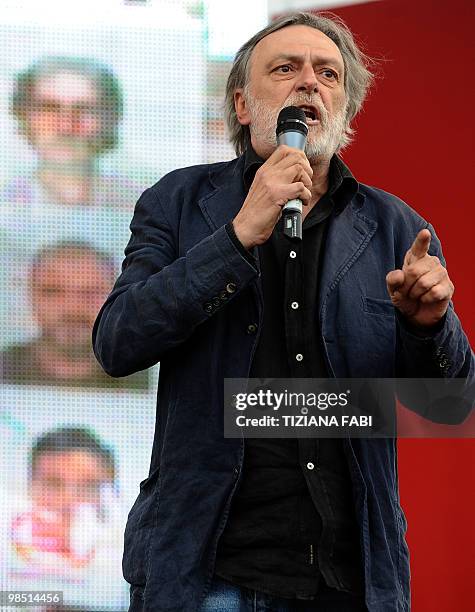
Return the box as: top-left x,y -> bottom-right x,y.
6,425 -> 126,612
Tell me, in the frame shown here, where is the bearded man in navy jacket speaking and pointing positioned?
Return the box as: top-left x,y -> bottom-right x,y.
94,9 -> 475,612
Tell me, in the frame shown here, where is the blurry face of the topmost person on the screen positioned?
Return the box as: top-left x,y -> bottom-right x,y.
25,71 -> 102,168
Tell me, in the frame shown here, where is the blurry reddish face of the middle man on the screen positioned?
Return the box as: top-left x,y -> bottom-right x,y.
31,251 -> 111,360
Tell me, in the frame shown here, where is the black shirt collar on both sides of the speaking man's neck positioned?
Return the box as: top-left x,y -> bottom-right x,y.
243,147 -> 358,214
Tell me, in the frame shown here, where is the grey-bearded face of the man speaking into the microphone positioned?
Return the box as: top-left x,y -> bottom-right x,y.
235,25 -> 346,160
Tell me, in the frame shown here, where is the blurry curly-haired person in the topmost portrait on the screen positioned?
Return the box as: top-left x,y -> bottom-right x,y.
2,56 -> 136,211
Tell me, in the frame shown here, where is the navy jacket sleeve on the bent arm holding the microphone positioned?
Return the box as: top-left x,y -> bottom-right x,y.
92,187 -> 258,376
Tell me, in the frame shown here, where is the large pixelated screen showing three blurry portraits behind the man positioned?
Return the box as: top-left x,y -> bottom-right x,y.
0,0 -> 266,612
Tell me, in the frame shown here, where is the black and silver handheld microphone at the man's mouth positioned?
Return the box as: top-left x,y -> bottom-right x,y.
276,106 -> 308,240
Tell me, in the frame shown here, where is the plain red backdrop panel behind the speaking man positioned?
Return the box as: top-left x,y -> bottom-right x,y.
304,0 -> 475,612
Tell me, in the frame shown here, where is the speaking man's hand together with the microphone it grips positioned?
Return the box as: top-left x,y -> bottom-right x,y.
233,106 -> 313,249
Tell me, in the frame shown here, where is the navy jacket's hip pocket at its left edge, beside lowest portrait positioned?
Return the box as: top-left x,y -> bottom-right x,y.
122,467 -> 160,586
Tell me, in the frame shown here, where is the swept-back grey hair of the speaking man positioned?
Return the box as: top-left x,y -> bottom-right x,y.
224,12 -> 374,155
